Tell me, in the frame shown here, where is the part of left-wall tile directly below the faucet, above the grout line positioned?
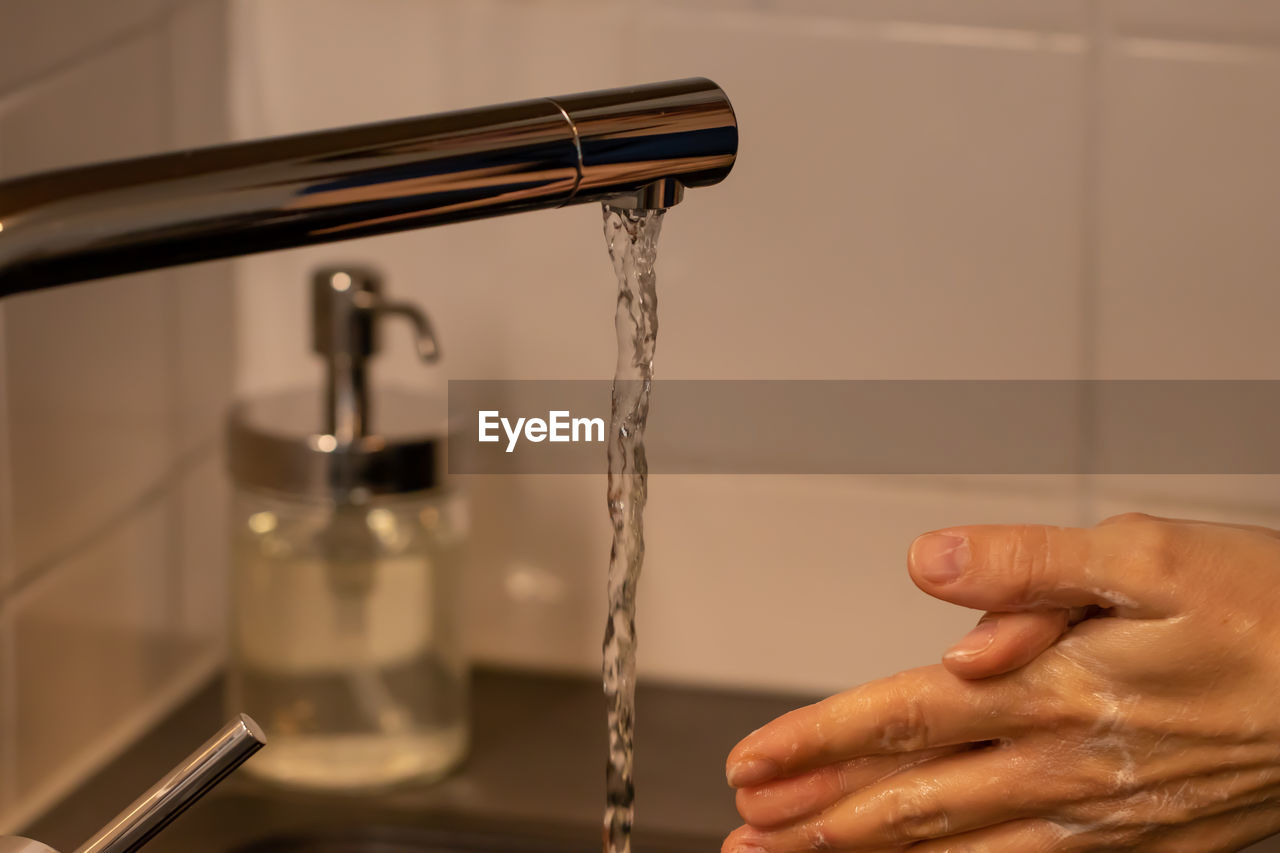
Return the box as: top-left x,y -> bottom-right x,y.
5,273 -> 175,578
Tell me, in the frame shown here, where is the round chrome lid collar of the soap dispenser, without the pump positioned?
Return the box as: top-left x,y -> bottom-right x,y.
227,391 -> 448,502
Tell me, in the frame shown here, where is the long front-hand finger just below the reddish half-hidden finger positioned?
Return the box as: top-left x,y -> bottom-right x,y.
739,747 -> 1060,853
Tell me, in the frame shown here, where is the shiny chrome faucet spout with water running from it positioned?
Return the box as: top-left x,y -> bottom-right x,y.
0,78 -> 737,297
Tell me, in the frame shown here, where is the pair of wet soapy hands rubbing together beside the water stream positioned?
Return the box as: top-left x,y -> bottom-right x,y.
723,516 -> 1280,853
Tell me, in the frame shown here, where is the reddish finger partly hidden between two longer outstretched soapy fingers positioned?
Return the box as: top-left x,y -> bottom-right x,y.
736,745 -> 969,827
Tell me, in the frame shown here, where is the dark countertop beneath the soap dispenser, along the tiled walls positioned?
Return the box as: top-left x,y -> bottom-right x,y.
24,670 -> 809,853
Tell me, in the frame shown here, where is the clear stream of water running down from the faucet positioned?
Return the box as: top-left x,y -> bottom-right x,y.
604,204 -> 663,853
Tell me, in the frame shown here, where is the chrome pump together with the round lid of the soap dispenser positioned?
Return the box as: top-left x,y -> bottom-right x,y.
228,266 -> 448,502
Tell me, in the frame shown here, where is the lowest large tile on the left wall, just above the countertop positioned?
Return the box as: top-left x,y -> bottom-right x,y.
12,501 -> 193,802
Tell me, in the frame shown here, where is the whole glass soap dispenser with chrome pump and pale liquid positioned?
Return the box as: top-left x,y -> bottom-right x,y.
228,266 -> 468,790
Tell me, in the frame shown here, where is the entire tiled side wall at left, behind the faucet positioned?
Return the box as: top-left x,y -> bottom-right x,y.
0,0 -> 233,833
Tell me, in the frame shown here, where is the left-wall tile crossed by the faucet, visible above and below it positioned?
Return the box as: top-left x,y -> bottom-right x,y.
0,26 -> 175,576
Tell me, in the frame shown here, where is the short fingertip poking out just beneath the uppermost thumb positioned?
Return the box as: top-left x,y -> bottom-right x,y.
942,610 -> 1069,679
